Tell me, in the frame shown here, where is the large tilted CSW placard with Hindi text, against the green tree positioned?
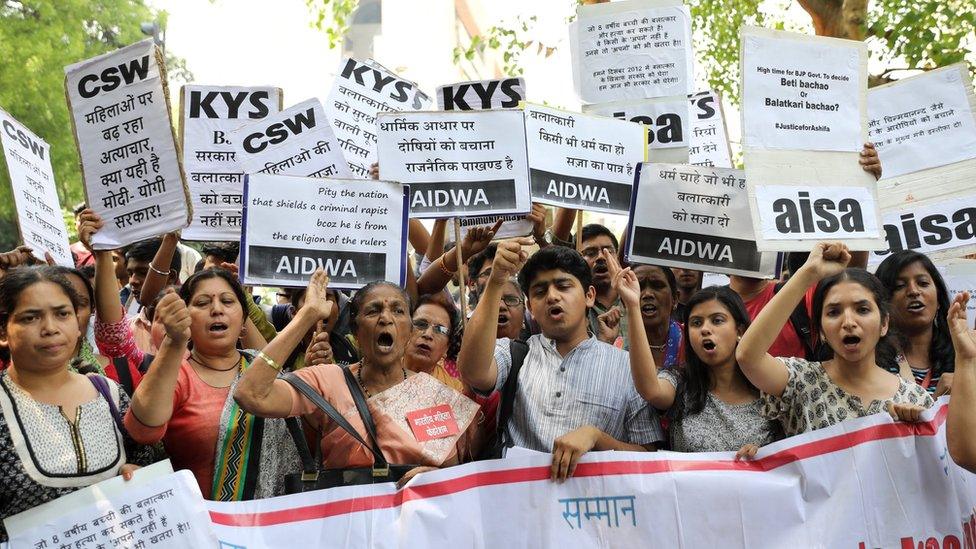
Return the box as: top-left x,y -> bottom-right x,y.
64,39 -> 192,250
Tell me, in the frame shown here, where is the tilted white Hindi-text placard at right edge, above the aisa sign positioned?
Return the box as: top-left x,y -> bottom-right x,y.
868,63 -> 976,179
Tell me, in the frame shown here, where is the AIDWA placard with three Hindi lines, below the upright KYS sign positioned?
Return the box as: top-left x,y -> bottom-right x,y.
377,110 -> 532,218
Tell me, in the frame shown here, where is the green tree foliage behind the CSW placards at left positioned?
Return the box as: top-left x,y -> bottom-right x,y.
0,0 -> 190,250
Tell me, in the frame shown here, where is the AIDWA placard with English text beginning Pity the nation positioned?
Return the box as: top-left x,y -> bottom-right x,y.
241,174 -> 409,289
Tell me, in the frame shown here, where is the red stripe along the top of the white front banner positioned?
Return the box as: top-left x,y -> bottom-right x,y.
210,406 -> 949,527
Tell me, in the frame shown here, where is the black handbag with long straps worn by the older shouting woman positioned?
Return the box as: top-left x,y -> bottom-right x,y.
282,367 -> 418,494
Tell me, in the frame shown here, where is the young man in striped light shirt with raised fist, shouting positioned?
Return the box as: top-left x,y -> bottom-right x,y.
458,238 -> 664,480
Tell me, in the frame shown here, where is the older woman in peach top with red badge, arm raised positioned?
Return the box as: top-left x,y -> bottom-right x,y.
234,270 -> 478,484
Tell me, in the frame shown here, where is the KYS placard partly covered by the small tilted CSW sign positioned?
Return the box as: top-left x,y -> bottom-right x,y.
180,84 -> 282,242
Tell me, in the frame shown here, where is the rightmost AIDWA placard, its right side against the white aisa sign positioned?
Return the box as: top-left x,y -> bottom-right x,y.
627,164 -> 778,278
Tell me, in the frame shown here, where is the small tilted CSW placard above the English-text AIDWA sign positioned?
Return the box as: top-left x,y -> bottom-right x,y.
231,99 -> 349,181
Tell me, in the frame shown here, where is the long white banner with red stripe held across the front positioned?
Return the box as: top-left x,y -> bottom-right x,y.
208,400 -> 976,549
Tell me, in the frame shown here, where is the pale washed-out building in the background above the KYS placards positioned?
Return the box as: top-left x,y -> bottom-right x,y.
342,0 -> 503,93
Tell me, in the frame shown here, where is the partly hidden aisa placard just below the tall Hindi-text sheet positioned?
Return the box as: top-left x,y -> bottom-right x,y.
583,95 -> 691,164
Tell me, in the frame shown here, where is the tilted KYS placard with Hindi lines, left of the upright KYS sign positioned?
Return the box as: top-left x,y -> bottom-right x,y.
325,57 -> 431,179
